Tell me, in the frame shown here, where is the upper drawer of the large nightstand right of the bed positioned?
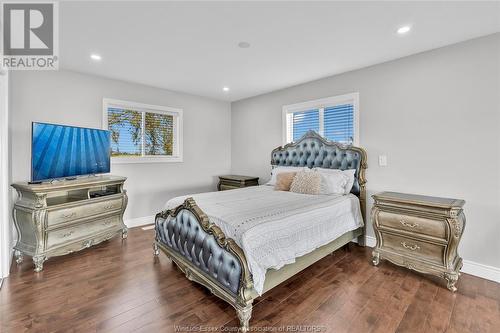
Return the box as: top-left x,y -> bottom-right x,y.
377,211 -> 446,239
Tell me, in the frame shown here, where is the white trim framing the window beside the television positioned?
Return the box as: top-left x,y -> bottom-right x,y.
102,98 -> 183,164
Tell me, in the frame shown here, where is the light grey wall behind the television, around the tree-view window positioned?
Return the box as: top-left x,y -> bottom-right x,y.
10,71 -> 231,222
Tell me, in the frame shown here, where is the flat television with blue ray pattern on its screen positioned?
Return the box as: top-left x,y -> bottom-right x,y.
31,122 -> 111,181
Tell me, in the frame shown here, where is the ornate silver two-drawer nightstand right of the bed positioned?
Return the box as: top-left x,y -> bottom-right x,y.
371,192 -> 465,292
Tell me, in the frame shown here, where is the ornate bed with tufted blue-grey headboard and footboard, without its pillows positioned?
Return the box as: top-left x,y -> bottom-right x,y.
153,131 -> 367,332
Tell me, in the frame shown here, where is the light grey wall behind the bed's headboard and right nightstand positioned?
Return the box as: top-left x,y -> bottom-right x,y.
231,34 -> 500,268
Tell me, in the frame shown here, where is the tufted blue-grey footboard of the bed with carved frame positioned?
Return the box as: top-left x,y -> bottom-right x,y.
153,198 -> 255,332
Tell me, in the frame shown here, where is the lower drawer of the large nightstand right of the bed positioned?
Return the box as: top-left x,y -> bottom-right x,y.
381,232 -> 445,265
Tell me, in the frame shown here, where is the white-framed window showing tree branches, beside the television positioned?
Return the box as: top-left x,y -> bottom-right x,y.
103,98 -> 182,163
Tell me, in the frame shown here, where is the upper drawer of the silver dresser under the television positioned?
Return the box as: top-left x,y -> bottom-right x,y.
47,198 -> 123,227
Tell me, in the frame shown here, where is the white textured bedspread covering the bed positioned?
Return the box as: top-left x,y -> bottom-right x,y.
166,185 -> 363,295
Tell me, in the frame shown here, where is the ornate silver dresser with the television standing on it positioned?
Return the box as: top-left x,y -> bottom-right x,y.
12,176 -> 127,272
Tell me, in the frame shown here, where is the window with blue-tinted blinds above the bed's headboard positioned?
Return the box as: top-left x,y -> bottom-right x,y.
283,93 -> 359,144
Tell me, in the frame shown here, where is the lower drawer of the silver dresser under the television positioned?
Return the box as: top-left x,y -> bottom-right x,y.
47,216 -> 121,249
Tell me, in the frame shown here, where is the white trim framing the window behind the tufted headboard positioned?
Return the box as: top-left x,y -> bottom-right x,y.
281,92 -> 359,146
